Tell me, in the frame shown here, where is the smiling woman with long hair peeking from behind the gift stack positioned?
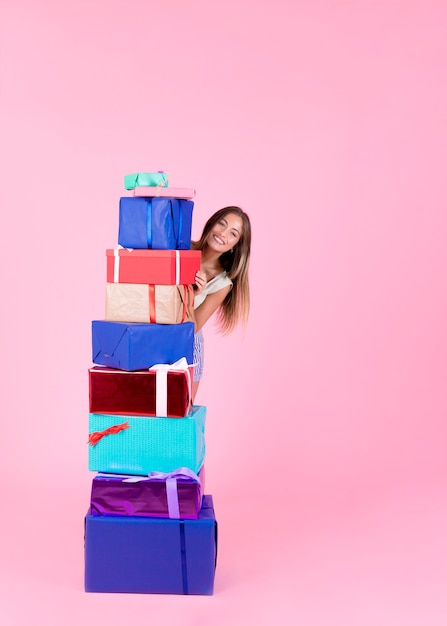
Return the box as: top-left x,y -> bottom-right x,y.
192,206 -> 251,401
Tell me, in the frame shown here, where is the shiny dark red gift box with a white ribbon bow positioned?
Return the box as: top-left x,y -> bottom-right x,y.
89,359 -> 194,417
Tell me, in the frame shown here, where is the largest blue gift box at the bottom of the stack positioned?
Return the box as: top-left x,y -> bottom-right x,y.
85,495 -> 217,595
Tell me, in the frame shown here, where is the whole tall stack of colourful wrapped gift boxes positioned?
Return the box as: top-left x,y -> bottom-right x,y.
85,172 -> 217,595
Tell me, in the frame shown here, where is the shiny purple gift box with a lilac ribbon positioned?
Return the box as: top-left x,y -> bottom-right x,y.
90,467 -> 204,519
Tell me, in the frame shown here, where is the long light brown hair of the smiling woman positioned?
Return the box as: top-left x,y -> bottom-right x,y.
191,206 -> 251,333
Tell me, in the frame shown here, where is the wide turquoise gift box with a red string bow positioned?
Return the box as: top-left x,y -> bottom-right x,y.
88,406 -> 206,476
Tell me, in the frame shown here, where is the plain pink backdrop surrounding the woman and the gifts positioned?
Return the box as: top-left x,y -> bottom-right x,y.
0,0 -> 447,626
